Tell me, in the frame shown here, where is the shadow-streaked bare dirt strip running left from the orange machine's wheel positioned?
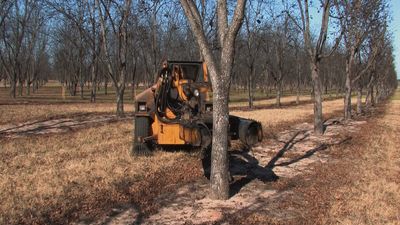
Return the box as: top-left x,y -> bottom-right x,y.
0,113 -> 133,138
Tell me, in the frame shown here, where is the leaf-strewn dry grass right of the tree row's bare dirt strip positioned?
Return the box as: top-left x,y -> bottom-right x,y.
222,91 -> 400,225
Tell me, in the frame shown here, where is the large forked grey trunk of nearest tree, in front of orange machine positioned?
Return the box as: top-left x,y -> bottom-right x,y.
180,0 -> 246,199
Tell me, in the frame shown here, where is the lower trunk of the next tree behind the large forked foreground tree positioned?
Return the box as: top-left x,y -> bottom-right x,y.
311,61 -> 324,135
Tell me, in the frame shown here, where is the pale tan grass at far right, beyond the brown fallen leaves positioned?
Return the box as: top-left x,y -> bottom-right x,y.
327,100 -> 400,224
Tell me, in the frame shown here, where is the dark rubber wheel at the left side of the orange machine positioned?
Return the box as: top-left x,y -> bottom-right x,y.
131,116 -> 152,156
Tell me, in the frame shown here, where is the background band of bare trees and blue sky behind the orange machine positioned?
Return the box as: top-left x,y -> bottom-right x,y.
0,0 -> 397,118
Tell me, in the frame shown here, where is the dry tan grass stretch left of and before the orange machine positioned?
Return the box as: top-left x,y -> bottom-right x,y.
0,122 -> 200,224
